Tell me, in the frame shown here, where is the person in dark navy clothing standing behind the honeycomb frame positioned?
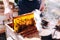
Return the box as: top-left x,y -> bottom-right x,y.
18,0 -> 44,15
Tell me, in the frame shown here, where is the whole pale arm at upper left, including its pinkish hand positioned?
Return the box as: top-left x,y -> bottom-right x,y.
3,0 -> 13,19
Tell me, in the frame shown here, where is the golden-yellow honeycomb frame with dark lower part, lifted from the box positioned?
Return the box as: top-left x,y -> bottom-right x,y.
14,12 -> 36,32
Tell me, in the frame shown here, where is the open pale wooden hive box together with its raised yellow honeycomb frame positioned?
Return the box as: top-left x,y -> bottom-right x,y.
6,13 -> 39,39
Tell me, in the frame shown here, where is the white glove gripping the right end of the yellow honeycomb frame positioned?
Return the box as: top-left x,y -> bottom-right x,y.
34,9 -> 42,32
